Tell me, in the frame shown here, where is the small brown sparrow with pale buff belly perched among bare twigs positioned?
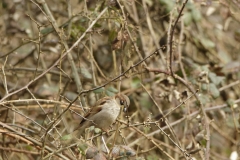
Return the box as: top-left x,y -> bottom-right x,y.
75,94 -> 130,135
